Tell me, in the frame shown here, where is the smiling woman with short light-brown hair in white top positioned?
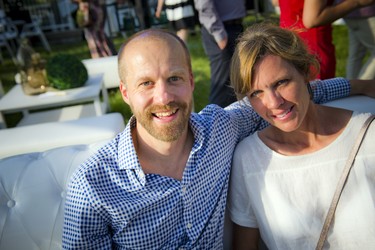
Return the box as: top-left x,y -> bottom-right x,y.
228,24 -> 375,249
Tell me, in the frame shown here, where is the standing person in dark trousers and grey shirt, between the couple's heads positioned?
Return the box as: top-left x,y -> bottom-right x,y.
194,0 -> 246,107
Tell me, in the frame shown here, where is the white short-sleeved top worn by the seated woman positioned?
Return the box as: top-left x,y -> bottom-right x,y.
228,112 -> 375,250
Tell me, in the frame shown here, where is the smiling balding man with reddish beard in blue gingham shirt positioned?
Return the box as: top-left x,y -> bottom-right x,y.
63,30 -> 372,249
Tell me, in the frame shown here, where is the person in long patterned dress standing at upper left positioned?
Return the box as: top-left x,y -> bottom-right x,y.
74,0 -> 116,58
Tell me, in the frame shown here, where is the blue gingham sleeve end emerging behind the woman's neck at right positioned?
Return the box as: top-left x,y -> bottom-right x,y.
310,77 -> 350,103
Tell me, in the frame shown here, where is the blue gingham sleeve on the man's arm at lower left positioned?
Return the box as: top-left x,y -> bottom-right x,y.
62,179 -> 112,249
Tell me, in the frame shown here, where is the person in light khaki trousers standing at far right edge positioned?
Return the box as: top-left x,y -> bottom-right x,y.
338,0 -> 375,79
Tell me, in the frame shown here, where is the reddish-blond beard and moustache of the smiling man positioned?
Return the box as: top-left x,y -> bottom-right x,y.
131,101 -> 192,142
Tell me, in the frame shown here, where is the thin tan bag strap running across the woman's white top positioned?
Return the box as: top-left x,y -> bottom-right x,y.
316,115 -> 375,250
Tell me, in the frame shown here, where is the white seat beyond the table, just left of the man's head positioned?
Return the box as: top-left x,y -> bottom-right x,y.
82,56 -> 120,89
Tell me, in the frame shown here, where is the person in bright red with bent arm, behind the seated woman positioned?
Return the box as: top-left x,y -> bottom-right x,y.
279,0 -> 374,79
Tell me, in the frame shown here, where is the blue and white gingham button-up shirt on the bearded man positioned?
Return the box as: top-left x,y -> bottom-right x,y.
63,79 -> 350,249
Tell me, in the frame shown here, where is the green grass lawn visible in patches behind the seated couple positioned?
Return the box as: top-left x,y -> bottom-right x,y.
0,13 -> 348,127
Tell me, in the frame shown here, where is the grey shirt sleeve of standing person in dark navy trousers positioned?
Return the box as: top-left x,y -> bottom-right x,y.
194,0 -> 228,42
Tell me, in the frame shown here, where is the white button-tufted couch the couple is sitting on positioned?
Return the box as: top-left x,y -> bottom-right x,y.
0,97 -> 375,250
